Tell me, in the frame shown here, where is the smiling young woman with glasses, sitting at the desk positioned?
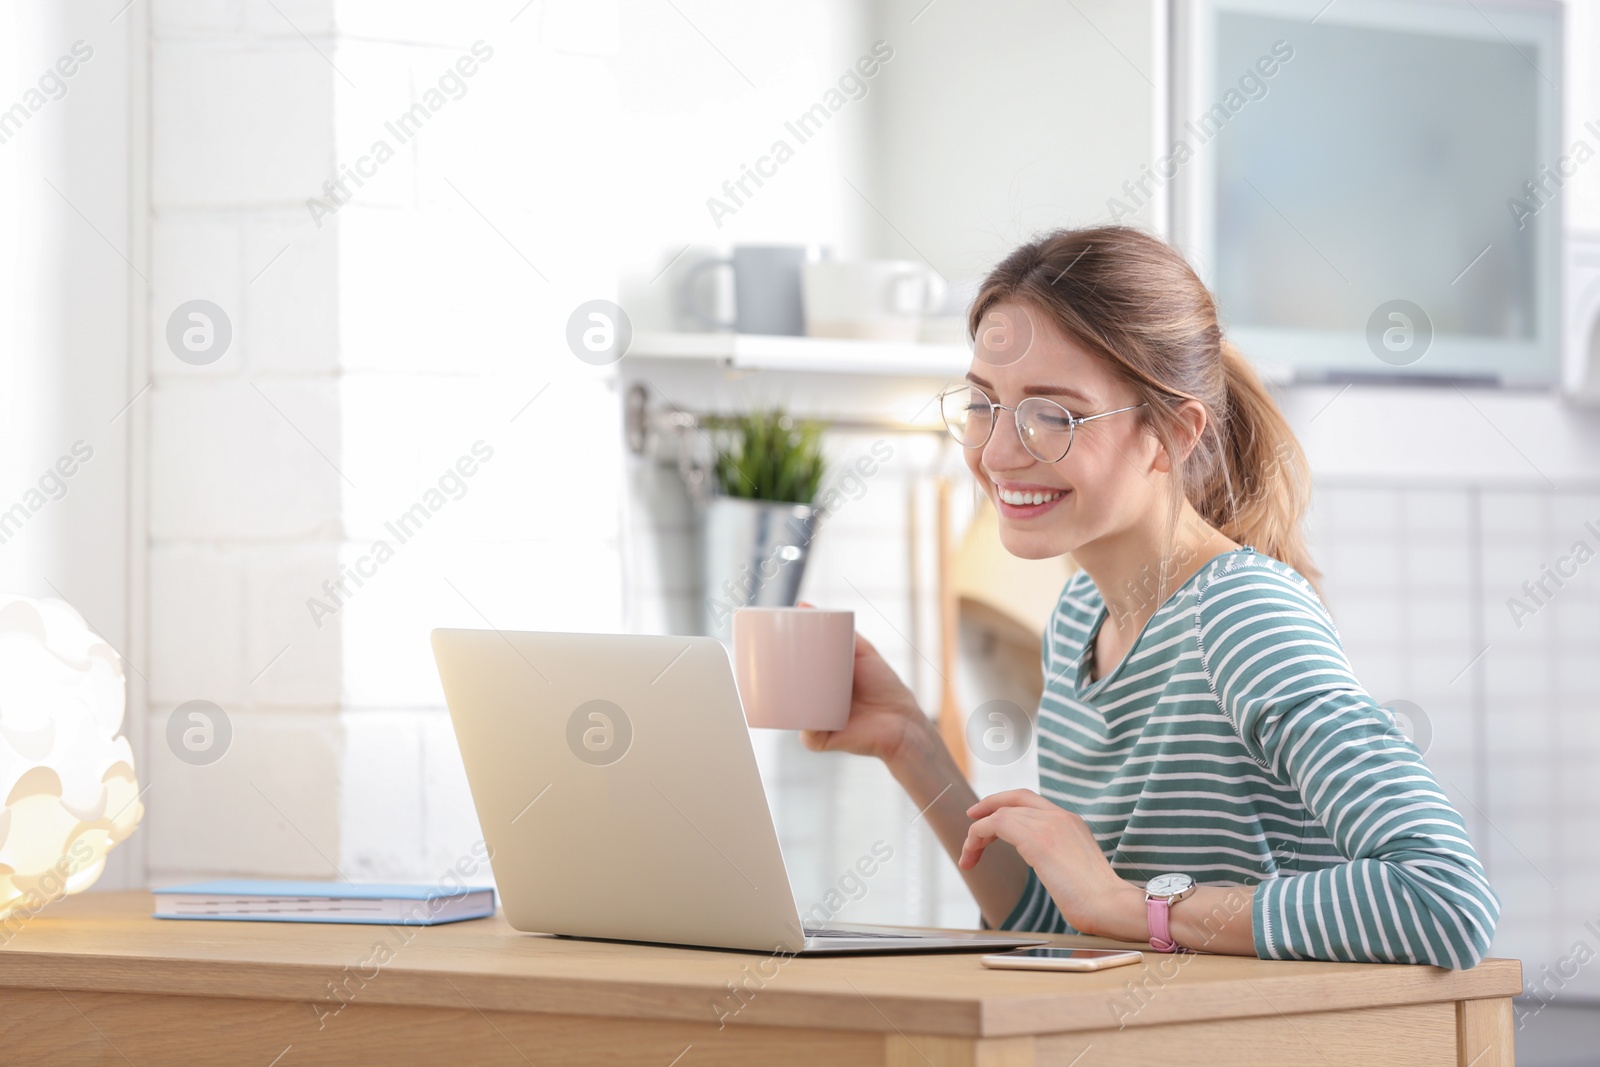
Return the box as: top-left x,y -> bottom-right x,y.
805,227 -> 1499,968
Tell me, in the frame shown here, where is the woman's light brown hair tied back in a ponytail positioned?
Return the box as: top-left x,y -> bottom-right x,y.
968,226 -> 1320,587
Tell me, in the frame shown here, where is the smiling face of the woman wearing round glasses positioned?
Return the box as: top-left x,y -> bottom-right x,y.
965,302 -> 1162,560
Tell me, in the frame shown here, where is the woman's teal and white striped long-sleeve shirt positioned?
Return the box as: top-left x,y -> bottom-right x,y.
1002,545 -> 1499,968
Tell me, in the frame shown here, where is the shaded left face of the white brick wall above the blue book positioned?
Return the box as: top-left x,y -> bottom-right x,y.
146,2 -> 353,883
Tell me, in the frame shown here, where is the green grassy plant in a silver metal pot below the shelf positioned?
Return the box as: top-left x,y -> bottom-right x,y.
701,408 -> 824,641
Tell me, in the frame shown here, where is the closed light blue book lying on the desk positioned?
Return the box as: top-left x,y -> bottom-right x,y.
155,878 -> 494,926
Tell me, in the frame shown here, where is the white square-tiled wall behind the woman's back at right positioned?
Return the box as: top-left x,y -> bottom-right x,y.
1312,482 -> 1600,997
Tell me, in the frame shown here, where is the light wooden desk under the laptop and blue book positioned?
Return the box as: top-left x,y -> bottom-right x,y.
0,893 -> 1522,1067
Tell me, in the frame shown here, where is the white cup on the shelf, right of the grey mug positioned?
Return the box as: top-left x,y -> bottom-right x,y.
802,259 -> 947,341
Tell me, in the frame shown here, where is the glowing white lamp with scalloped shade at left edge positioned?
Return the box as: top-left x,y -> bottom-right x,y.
0,593 -> 144,920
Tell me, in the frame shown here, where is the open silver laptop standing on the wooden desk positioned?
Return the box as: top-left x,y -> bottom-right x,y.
432,630 -> 1048,955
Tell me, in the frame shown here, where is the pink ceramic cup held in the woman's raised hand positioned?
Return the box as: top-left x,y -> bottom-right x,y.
733,608 -> 856,729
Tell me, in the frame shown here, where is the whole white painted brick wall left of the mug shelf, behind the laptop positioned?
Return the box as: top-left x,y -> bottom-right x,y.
149,0 -> 622,881
